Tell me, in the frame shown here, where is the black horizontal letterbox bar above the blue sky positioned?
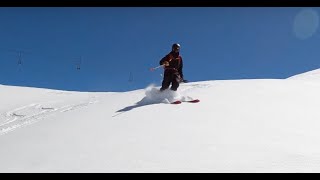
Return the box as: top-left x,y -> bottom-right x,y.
0,0 -> 320,7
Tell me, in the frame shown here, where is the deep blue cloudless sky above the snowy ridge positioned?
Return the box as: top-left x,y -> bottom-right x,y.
0,7 -> 320,91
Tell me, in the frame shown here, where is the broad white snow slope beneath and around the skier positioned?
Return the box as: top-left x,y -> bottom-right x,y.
0,69 -> 320,172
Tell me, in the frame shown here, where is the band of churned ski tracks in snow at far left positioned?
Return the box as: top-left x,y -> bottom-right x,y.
0,97 -> 98,135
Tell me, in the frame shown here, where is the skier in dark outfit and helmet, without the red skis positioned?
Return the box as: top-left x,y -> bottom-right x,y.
159,43 -> 187,91
